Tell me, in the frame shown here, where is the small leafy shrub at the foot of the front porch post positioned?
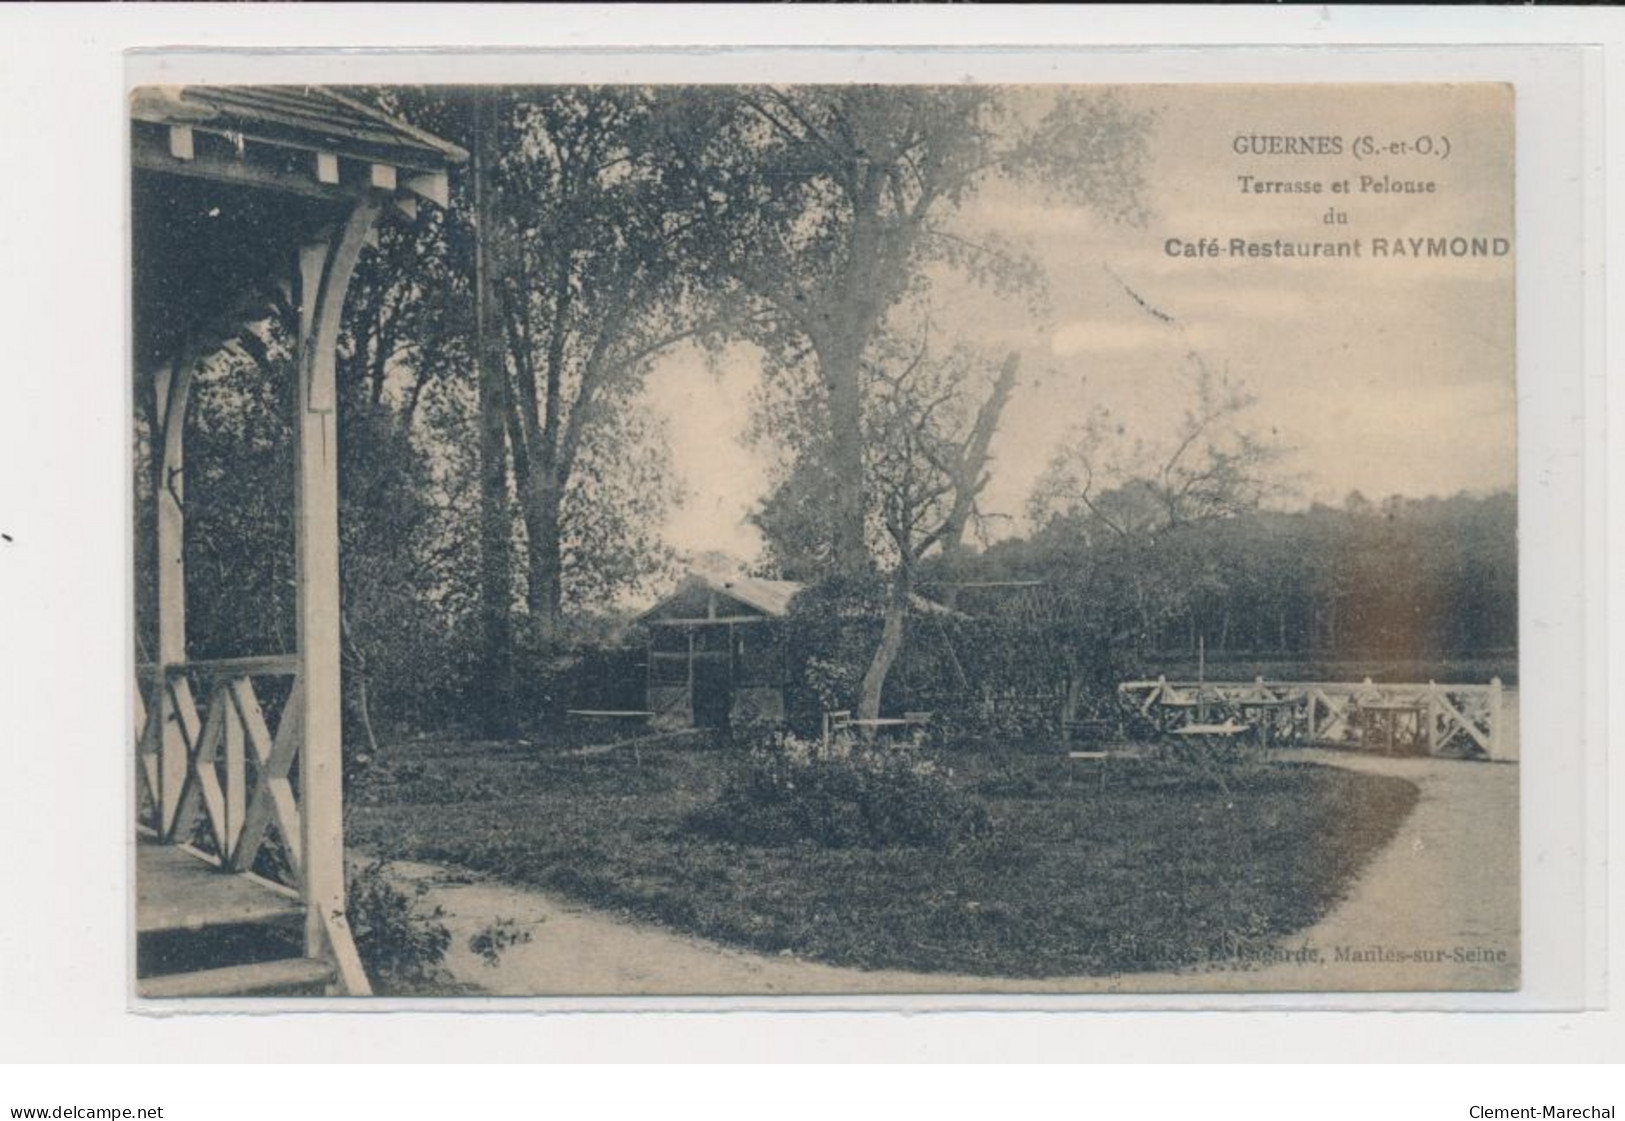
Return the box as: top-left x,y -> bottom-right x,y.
346,861 -> 452,994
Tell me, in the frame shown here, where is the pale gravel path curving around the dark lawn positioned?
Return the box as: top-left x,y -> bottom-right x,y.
392,751 -> 1518,996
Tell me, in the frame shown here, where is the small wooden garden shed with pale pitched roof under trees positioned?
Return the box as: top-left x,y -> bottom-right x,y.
639,575 -> 803,728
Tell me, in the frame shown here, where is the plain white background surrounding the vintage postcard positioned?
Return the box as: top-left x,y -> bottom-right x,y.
0,5 -> 1625,1098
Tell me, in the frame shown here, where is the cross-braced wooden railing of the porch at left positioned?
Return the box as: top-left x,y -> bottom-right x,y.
135,655 -> 307,890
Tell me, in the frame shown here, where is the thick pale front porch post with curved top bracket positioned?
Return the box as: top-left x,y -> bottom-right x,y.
294,200 -> 379,996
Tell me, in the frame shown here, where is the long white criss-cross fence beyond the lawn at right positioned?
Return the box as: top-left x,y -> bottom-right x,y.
1118,677 -> 1510,759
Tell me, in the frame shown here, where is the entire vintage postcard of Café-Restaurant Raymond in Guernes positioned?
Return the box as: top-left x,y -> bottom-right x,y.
128,83 -> 1523,1002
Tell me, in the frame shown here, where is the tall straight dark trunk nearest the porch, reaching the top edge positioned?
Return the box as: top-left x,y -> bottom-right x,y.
473,91 -> 515,739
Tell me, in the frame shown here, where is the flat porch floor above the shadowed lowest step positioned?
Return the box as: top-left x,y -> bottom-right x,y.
135,843 -> 304,934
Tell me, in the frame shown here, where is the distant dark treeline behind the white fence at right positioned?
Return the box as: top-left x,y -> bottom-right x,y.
946,492 -> 1518,668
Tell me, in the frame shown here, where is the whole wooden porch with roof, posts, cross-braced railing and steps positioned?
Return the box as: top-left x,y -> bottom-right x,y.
130,86 -> 466,998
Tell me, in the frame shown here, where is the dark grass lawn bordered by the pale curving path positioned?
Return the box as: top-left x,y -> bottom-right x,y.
348,741 -> 1417,976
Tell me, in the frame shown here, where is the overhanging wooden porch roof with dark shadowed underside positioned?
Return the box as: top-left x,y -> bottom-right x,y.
130,86 -> 468,374
